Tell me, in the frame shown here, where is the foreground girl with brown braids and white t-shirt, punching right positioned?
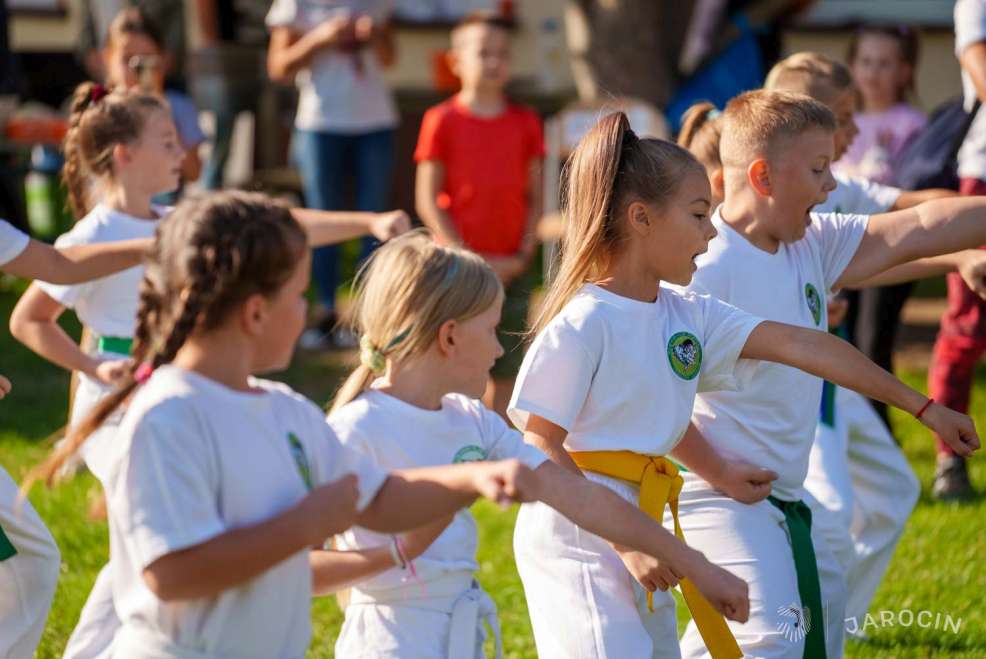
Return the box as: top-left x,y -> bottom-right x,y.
21,194 -> 533,659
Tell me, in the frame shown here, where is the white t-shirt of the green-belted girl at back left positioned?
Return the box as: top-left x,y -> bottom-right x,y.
38,204 -> 165,338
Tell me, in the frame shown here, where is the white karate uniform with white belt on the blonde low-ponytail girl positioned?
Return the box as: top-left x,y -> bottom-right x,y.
329,389 -> 547,659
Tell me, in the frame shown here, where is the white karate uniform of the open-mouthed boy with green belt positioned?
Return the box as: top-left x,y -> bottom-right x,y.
682,210 -> 868,659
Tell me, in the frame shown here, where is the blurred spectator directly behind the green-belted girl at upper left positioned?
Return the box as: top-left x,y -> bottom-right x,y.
102,7 -> 205,199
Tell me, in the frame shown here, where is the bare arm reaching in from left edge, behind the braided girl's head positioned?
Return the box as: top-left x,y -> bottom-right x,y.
3,238 -> 153,284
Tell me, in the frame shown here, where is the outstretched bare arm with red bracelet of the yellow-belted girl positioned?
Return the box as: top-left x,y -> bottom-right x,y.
740,321 -> 979,456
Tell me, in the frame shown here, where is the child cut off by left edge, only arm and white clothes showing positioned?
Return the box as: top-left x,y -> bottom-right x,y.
0,220 -> 150,657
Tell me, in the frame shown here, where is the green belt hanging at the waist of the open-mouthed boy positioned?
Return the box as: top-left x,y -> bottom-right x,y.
767,496 -> 826,659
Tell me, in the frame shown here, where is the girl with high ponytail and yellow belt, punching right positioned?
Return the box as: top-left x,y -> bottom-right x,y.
509,115 -> 971,657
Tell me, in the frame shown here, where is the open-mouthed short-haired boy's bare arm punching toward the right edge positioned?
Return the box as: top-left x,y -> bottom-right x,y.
833,197 -> 986,289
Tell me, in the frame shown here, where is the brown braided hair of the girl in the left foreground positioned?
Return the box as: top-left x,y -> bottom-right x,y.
22,193 -> 307,492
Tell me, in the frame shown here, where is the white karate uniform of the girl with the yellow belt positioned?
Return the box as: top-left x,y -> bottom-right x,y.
508,285 -> 761,659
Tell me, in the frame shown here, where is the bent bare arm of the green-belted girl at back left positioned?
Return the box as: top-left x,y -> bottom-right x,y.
10,284 -> 100,378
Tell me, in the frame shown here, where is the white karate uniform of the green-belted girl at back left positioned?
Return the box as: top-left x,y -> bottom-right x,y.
38,204 -> 164,659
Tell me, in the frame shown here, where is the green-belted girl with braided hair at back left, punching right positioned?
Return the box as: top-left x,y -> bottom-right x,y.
10,83 -> 409,659
